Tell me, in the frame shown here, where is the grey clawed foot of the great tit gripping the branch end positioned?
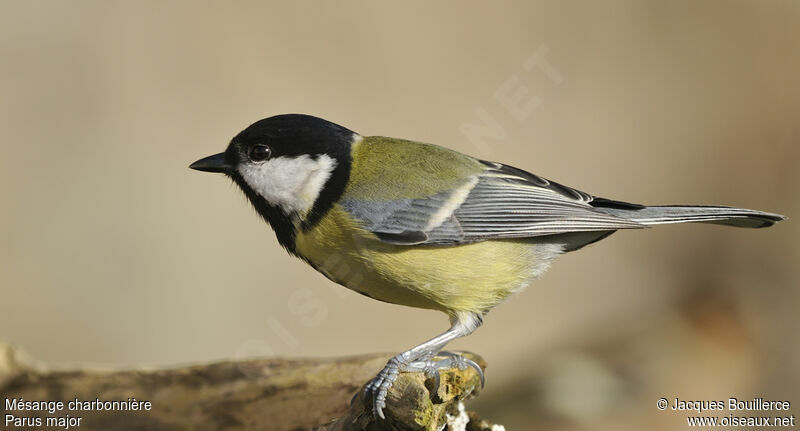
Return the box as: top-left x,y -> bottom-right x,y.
365,352 -> 485,419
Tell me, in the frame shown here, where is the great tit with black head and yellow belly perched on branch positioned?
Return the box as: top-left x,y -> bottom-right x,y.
190,114 -> 785,418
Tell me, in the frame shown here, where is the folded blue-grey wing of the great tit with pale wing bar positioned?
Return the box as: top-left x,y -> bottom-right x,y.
341,162 -> 646,245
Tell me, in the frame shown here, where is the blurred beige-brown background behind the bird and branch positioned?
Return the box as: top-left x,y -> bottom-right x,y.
0,1 -> 800,430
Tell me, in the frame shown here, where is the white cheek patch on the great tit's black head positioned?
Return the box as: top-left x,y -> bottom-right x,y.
239,154 -> 336,216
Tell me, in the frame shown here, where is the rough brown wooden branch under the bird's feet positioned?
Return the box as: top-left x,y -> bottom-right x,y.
0,345 -> 500,431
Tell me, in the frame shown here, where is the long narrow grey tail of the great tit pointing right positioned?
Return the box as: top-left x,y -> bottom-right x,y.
595,205 -> 786,228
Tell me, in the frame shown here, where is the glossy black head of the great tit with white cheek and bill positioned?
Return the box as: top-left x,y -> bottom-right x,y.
189,114 -> 358,251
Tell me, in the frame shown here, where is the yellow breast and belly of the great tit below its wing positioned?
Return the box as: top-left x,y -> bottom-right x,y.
295,205 -> 561,314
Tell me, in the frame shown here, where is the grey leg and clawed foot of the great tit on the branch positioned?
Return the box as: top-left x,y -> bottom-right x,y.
366,313 -> 483,419
